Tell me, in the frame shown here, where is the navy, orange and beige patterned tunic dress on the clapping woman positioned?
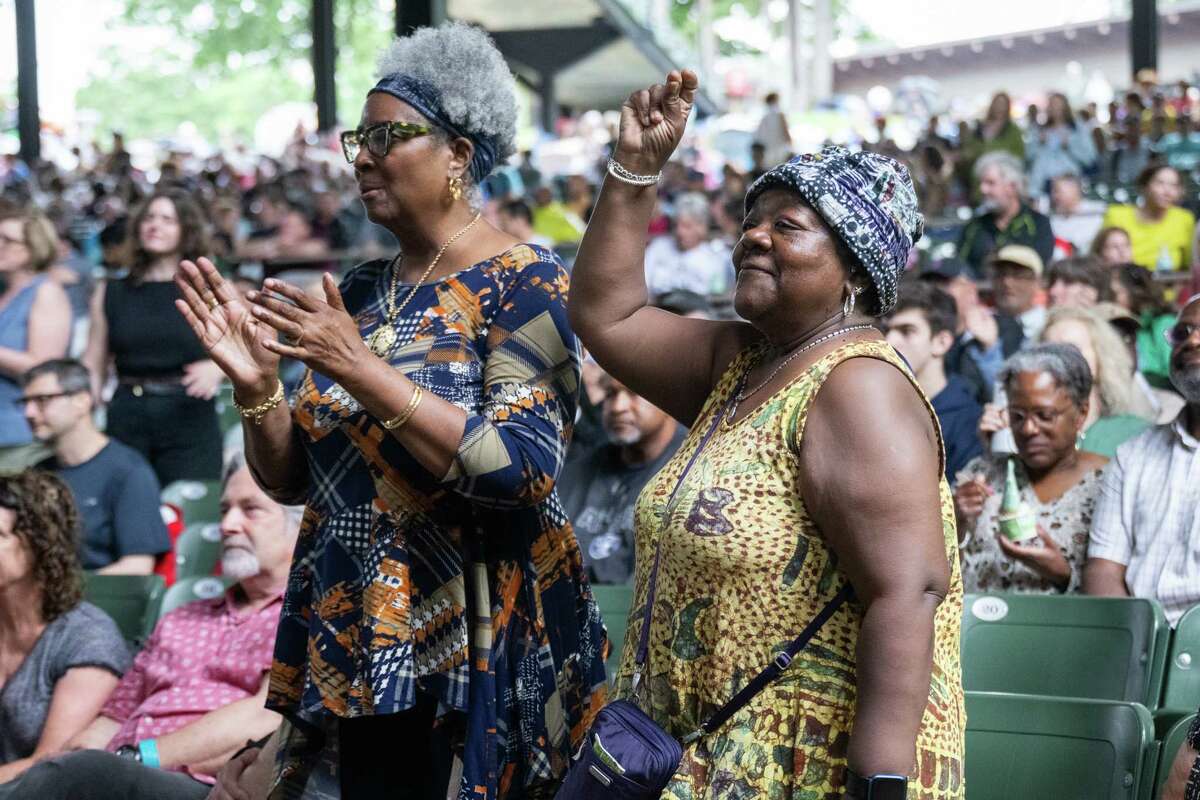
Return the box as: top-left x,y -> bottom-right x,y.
268,245 -> 607,800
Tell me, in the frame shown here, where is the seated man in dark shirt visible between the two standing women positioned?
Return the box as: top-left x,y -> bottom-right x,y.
558,375 -> 686,583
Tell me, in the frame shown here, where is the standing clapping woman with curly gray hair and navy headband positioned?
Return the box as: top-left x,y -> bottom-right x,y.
179,24 -> 607,800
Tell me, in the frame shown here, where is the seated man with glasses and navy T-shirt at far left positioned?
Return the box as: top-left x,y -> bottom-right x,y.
22,359 -> 170,575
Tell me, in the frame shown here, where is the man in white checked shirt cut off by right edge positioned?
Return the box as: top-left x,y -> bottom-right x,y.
1084,295 -> 1200,625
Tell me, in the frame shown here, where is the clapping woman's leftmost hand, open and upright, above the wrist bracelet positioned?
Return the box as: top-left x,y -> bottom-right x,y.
175,258 -> 280,402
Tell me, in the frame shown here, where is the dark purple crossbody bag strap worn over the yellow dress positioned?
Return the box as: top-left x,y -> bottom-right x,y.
630,374 -> 854,745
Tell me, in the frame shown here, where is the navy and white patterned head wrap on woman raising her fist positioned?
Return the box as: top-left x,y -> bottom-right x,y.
746,146 -> 924,314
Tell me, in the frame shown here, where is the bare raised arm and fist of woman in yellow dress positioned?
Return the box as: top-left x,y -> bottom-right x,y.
568,70 -> 754,426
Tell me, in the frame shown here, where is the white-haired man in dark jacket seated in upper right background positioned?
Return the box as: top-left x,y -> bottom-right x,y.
958,152 -> 1055,279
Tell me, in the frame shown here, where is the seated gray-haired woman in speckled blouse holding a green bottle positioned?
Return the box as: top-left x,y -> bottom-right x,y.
954,344 -> 1109,594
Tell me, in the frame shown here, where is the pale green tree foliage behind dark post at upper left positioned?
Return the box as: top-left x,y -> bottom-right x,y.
77,0 -> 391,138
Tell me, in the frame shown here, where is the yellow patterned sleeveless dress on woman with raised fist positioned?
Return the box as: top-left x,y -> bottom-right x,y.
617,342 -> 966,800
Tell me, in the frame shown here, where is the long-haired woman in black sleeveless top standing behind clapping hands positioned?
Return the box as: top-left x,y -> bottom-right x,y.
84,191 -> 222,486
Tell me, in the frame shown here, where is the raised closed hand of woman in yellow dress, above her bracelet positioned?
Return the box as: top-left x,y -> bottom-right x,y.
613,70 -> 700,175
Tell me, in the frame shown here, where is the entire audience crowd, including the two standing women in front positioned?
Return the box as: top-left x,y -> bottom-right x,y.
0,17 -> 1200,800
